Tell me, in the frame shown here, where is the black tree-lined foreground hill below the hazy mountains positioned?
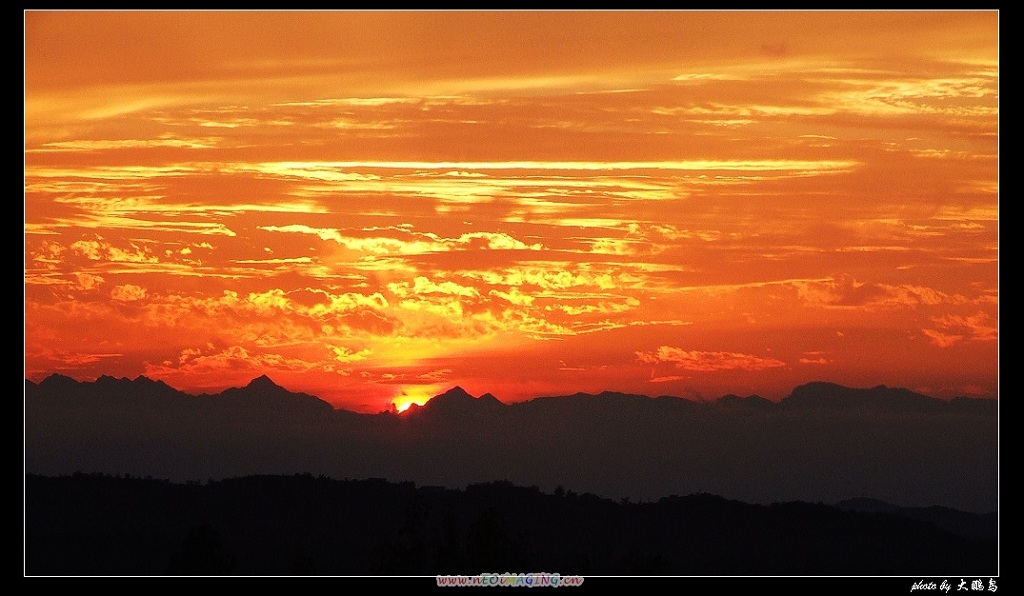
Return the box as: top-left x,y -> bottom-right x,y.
25,474 -> 998,577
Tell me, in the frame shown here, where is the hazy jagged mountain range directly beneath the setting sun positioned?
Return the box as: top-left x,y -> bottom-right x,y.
25,374 -> 998,512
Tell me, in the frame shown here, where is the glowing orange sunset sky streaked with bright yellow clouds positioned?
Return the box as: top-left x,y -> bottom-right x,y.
25,11 -> 998,412
